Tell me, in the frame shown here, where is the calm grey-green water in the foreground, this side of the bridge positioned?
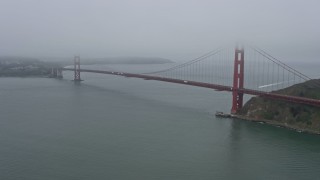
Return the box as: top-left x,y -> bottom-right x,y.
0,64 -> 320,180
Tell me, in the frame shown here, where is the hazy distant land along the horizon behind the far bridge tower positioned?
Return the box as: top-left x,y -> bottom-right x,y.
0,56 -> 172,77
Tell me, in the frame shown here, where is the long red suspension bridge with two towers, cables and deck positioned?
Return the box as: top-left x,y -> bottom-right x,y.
53,47 -> 320,114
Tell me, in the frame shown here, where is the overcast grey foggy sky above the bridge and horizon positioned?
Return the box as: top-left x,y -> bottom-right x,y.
0,0 -> 320,60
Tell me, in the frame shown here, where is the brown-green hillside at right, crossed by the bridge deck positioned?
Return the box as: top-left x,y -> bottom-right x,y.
238,79 -> 320,134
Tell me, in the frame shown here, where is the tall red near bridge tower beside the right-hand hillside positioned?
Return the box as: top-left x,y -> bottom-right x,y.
231,47 -> 244,114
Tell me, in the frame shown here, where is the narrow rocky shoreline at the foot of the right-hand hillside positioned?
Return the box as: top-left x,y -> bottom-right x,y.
232,115 -> 320,135
